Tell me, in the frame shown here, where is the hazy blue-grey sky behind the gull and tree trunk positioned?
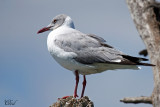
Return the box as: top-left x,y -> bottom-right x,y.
0,0 -> 153,107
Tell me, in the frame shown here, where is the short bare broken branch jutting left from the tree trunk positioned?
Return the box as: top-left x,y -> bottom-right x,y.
120,96 -> 152,104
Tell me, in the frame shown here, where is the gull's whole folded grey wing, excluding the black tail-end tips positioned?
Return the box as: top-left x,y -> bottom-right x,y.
55,32 -> 129,64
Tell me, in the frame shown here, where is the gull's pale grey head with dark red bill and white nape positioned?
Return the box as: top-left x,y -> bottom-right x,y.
37,14 -> 74,33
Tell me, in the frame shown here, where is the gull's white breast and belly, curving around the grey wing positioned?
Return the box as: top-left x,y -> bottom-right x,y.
47,27 -> 93,71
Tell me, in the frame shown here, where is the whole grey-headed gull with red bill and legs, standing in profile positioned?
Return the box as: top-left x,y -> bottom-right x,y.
37,14 -> 154,98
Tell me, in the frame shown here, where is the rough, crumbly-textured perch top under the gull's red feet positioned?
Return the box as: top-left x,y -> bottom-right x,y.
50,96 -> 94,107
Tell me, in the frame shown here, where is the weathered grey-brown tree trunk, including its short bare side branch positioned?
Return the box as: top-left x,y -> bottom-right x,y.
121,0 -> 160,107
